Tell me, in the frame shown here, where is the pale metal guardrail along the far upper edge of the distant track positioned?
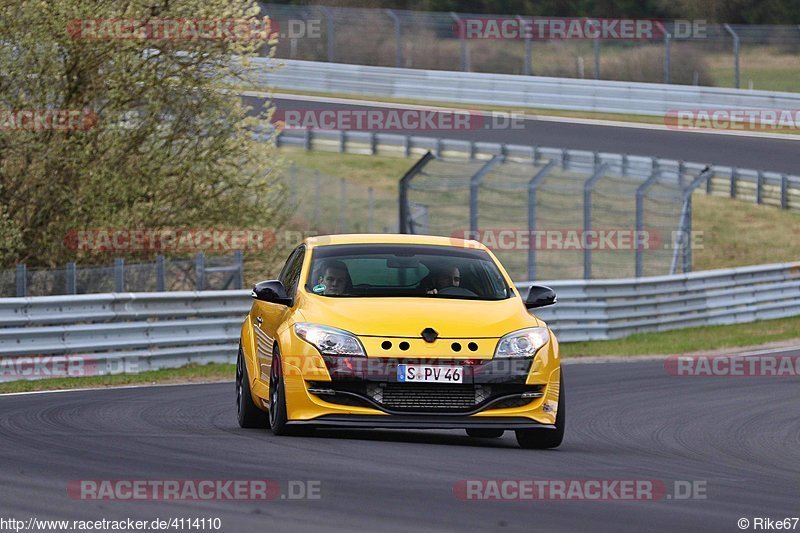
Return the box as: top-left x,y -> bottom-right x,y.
253,58 -> 800,116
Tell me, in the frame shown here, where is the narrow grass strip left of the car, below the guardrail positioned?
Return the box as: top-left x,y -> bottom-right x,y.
0,363 -> 236,394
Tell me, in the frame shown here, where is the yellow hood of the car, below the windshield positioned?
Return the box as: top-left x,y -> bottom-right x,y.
300,294 -> 544,338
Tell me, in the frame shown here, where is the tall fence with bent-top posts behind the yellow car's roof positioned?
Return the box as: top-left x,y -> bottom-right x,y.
400,150 -> 708,280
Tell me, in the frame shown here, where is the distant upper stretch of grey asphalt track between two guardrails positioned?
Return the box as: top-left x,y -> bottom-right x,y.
255,97 -> 800,174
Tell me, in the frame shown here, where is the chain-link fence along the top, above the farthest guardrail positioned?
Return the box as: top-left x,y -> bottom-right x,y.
262,3 -> 800,91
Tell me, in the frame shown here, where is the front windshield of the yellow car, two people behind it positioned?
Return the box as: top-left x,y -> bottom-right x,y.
305,244 -> 513,300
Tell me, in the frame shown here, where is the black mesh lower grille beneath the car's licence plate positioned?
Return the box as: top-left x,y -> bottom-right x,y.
367,382 -> 491,411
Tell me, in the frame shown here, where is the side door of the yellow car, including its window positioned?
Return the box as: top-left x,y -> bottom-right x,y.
253,246 -> 306,381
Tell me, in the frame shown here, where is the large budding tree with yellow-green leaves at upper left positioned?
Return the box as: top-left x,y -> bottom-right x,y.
0,0 -> 283,266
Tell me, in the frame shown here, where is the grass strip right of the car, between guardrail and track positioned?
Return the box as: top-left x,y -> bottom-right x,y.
561,316 -> 800,358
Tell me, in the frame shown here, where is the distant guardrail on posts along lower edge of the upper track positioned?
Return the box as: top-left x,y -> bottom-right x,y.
277,129 -> 800,211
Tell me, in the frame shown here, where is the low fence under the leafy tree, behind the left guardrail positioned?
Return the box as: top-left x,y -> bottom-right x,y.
0,252 -> 244,297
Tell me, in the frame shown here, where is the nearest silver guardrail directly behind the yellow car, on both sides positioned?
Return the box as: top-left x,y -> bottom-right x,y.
0,262 -> 800,381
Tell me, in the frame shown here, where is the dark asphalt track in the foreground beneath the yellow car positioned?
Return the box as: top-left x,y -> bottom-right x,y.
0,354 -> 800,531
